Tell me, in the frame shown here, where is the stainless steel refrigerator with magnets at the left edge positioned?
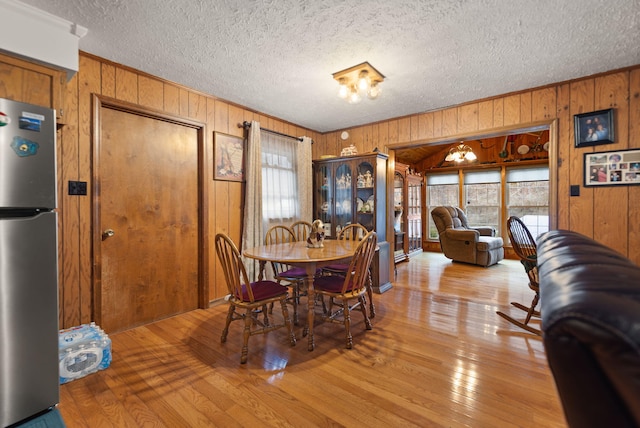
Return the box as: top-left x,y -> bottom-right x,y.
0,99 -> 59,427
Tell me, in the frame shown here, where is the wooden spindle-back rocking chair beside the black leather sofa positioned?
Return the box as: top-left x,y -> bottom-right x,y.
496,216 -> 541,335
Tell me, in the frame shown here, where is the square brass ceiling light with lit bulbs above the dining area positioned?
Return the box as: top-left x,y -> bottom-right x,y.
333,61 -> 384,104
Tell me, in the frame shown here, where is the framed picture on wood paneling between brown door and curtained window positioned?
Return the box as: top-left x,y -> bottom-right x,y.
213,132 -> 244,181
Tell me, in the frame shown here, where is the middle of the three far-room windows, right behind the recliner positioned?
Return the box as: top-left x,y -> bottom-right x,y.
464,170 -> 501,235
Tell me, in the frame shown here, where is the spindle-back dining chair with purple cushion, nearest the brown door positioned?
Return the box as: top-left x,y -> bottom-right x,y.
215,233 -> 296,364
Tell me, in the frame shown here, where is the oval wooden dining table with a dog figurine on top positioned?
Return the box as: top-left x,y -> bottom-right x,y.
242,239 -> 359,351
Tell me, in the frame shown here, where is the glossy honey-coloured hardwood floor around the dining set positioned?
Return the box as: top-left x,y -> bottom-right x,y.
60,253 -> 567,428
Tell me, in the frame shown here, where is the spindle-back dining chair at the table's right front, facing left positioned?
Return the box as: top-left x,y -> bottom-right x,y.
313,232 -> 378,349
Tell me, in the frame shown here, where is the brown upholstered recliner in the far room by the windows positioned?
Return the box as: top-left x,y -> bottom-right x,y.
431,207 -> 504,267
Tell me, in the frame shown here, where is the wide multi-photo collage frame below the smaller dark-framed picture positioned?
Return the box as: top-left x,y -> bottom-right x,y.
584,149 -> 640,187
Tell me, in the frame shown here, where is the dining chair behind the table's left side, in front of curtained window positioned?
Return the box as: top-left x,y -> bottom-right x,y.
264,225 -> 307,325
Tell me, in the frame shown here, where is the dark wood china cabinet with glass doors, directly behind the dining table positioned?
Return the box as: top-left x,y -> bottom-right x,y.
313,153 -> 391,292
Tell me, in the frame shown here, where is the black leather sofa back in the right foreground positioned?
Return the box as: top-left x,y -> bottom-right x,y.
538,230 -> 640,428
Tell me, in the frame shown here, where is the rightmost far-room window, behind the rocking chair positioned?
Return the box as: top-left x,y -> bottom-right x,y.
506,166 -> 549,238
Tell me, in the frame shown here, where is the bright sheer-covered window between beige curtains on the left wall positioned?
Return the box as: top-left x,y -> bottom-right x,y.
260,132 -> 300,230
